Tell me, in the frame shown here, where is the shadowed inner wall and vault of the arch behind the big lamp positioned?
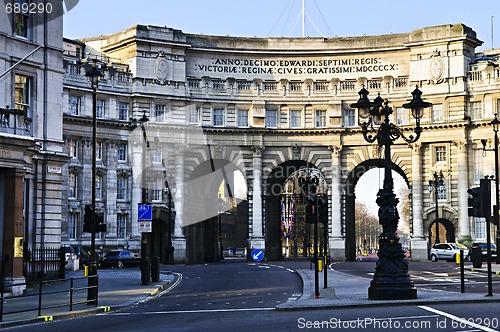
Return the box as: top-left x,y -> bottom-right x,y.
344,159 -> 409,261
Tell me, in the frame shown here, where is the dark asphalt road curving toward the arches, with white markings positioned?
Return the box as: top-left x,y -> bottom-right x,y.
6,261 -> 500,332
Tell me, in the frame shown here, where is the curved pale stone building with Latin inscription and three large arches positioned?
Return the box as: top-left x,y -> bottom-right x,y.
61,24 -> 500,263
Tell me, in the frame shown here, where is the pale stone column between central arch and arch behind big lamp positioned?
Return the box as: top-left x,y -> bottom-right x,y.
328,145 -> 345,260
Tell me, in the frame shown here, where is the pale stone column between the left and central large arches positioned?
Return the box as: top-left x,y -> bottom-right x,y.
250,145 -> 265,249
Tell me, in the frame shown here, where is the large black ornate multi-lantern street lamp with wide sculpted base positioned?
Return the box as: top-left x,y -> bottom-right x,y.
350,87 -> 432,300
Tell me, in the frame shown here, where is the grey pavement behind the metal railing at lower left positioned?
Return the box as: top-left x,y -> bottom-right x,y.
0,266 -> 177,328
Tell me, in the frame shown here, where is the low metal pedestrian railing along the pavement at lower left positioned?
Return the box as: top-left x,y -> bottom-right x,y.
0,275 -> 99,322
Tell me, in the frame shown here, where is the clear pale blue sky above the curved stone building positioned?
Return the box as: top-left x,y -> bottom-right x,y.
64,0 -> 500,49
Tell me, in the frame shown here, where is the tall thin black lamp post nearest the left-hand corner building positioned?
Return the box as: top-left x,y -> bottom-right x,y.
85,59 -> 104,305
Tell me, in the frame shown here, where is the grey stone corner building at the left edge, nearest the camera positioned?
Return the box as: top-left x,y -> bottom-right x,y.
0,4 -> 68,293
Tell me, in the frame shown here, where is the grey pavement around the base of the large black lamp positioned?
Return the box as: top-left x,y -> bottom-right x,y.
276,262 -> 500,310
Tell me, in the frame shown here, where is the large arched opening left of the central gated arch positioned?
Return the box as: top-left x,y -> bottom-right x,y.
184,159 -> 248,264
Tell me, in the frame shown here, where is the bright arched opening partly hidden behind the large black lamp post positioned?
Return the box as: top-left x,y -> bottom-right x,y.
344,159 -> 411,261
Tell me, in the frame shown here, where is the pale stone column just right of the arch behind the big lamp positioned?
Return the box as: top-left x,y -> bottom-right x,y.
410,143 -> 428,261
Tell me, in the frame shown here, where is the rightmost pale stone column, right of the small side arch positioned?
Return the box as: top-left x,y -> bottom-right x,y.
453,141 -> 472,243
